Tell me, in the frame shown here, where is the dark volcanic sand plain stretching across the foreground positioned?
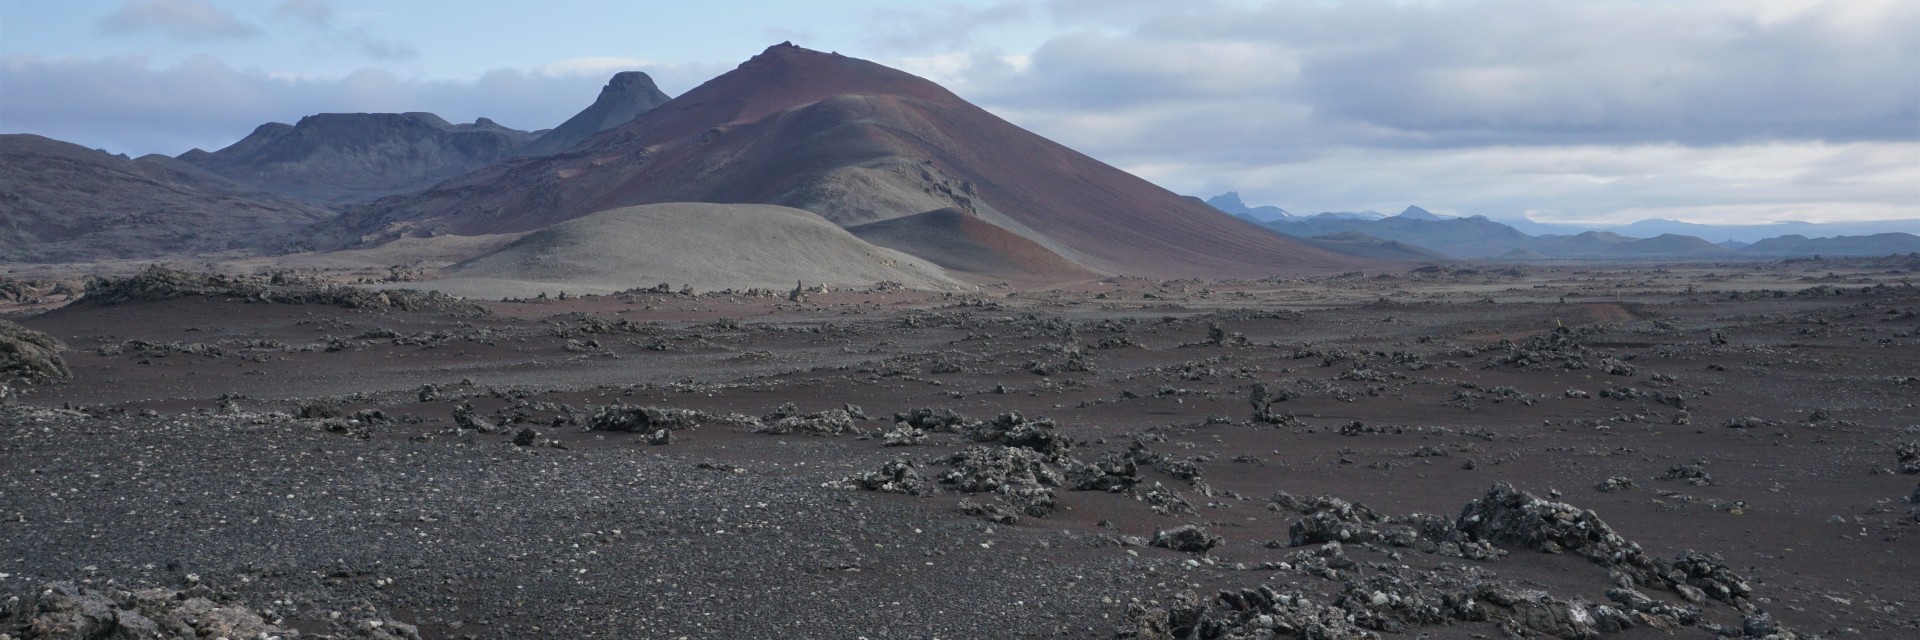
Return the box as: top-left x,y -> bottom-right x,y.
0,261 -> 1920,638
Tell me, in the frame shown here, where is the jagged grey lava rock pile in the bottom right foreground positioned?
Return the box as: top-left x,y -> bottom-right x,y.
1114,484 -> 1799,640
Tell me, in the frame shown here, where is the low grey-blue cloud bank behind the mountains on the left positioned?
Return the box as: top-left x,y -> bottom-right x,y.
0,56 -> 720,156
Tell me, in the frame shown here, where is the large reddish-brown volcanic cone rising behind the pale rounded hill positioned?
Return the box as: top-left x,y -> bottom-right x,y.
334,44 -> 1375,279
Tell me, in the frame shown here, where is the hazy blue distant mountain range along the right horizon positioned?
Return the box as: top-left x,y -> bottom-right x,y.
1208,192 -> 1920,259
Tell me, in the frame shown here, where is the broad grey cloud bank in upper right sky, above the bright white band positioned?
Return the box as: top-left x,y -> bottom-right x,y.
956,0 -> 1920,148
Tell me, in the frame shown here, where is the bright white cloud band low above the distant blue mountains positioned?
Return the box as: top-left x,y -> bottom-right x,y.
1123,142 -> 1920,223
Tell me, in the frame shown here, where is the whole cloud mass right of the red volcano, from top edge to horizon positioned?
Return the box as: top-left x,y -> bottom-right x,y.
887,0 -> 1920,221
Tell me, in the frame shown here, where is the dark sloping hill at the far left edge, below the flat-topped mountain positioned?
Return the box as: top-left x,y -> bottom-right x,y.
0,135 -> 334,261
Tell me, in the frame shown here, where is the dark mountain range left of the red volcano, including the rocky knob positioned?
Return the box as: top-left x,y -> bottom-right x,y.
0,71 -> 668,263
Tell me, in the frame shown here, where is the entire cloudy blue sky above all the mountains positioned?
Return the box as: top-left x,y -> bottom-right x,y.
0,0 -> 1920,231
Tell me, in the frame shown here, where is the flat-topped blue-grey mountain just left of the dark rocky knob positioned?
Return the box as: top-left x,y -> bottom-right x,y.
180,113 -> 534,202
